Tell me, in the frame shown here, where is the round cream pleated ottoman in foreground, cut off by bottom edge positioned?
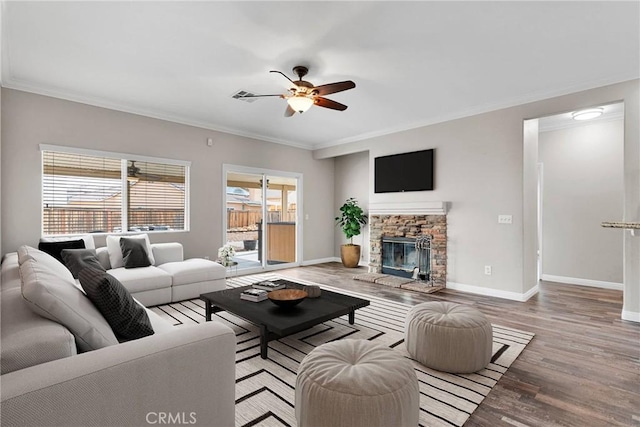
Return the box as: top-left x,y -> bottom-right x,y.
295,340 -> 420,427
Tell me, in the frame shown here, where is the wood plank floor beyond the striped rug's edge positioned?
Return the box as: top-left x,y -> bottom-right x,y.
277,263 -> 640,426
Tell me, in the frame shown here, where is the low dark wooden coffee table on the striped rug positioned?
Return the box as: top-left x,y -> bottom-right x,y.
200,279 -> 369,359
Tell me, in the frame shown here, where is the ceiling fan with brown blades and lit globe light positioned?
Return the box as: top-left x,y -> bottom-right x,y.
244,65 -> 356,117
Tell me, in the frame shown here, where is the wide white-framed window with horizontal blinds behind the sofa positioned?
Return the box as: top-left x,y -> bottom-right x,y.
41,145 -> 190,235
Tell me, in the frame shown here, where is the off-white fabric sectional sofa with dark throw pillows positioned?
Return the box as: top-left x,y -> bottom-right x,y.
0,244 -> 236,426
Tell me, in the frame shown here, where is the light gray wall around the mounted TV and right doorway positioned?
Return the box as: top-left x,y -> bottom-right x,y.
314,80 -> 640,320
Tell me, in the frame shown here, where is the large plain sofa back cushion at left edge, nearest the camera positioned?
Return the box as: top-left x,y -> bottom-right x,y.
0,288 -> 77,375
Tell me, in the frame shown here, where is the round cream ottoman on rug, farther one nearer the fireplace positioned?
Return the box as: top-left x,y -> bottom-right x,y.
404,302 -> 493,373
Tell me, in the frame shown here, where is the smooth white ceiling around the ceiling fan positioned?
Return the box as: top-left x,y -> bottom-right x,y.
2,1 -> 640,149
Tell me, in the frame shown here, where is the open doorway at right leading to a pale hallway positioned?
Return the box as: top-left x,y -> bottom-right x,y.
525,103 -> 624,290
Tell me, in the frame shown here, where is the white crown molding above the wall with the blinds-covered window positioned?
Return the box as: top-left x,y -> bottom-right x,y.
2,76 -> 312,150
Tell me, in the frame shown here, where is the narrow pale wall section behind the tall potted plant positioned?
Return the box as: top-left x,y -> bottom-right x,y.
334,151 -> 369,264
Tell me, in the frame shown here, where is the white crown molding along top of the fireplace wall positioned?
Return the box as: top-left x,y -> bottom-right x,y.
313,74 -> 640,150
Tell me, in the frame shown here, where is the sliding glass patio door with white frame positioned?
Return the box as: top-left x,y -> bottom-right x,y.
223,165 -> 302,274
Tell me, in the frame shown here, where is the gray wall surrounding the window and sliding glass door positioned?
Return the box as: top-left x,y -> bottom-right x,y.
1,89 -> 334,260
